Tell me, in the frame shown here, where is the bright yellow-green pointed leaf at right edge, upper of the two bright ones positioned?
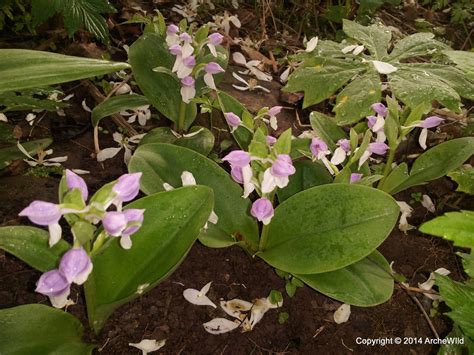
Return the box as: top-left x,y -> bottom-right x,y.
420,211 -> 474,250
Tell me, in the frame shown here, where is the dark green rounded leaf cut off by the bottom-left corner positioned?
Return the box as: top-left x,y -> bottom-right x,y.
0,304 -> 95,355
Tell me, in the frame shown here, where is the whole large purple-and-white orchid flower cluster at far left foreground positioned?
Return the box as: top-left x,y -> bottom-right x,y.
19,170 -> 145,308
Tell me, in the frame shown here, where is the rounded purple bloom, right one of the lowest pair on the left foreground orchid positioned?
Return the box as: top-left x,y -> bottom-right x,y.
59,248 -> 92,285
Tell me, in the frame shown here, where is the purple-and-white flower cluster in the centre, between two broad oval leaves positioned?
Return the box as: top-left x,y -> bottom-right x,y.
222,136 -> 296,225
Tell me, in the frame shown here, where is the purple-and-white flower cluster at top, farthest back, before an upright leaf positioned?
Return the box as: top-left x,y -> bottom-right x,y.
166,25 -> 225,103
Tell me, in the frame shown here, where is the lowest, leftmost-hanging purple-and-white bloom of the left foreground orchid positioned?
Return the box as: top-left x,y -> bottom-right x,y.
35,269 -> 71,308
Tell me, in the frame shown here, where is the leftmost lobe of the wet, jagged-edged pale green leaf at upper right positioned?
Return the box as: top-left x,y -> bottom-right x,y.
284,57 -> 367,108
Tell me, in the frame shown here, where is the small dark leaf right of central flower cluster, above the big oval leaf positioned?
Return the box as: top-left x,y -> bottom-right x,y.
277,160 -> 332,203
